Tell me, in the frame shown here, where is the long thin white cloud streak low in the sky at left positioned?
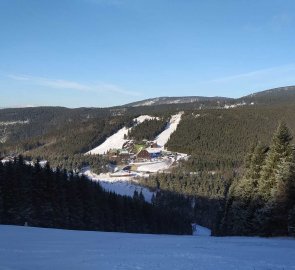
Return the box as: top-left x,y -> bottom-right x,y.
6,74 -> 141,96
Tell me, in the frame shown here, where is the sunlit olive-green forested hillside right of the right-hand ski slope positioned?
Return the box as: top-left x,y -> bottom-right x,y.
167,105 -> 295,171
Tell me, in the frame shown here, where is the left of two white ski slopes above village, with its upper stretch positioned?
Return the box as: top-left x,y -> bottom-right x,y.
86,115 -> 156,155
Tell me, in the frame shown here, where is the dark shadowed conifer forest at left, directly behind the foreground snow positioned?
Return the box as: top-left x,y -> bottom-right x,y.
0,156 -> 191,234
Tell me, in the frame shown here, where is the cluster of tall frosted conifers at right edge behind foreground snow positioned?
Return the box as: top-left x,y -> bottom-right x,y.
222,123 -> 295,236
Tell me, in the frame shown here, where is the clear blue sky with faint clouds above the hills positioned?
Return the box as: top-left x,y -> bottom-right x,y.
0,0 -> 295,107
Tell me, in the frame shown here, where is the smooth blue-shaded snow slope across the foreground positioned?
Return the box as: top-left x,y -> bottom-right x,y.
0,225 -> 295,270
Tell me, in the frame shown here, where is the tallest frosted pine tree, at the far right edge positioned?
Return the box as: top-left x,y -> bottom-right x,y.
255,123 -> 295,235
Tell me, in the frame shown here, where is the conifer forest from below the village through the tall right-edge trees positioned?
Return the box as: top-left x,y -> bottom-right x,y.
141,123 -> 295,236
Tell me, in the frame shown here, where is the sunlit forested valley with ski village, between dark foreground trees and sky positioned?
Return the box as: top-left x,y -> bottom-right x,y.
0,87 -> 295,235
